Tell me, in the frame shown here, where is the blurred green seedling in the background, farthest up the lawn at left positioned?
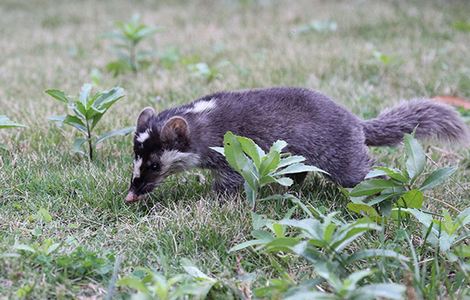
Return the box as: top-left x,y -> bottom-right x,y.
106,15 -> 159,76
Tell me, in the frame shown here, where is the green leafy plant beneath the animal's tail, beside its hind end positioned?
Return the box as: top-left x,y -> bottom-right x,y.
348,134 -> 457,219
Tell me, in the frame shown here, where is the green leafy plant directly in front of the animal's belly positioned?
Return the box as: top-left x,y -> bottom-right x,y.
212,131 -> 326,209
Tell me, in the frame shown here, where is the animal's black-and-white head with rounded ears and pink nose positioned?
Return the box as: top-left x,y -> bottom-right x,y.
125,107 -> 199,202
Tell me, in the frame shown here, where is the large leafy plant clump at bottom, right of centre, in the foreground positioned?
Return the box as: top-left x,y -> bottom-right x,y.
230,196 -> 409,299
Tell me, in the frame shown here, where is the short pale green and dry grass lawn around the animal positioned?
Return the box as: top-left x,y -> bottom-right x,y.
0,0 -> 470,298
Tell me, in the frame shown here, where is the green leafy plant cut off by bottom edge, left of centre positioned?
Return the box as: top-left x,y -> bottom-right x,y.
117,259 -> 218,300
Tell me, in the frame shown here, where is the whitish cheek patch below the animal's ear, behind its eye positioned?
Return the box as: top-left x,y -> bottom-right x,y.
160,150 -> 200,175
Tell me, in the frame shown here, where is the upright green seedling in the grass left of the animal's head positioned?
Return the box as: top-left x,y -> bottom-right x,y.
46,83 -> 134,160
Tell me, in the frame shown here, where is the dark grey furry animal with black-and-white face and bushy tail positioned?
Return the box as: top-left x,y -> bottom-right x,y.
126,87 -> 470,202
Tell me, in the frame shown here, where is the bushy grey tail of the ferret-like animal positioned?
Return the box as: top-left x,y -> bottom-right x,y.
363,100 -> 470,146
